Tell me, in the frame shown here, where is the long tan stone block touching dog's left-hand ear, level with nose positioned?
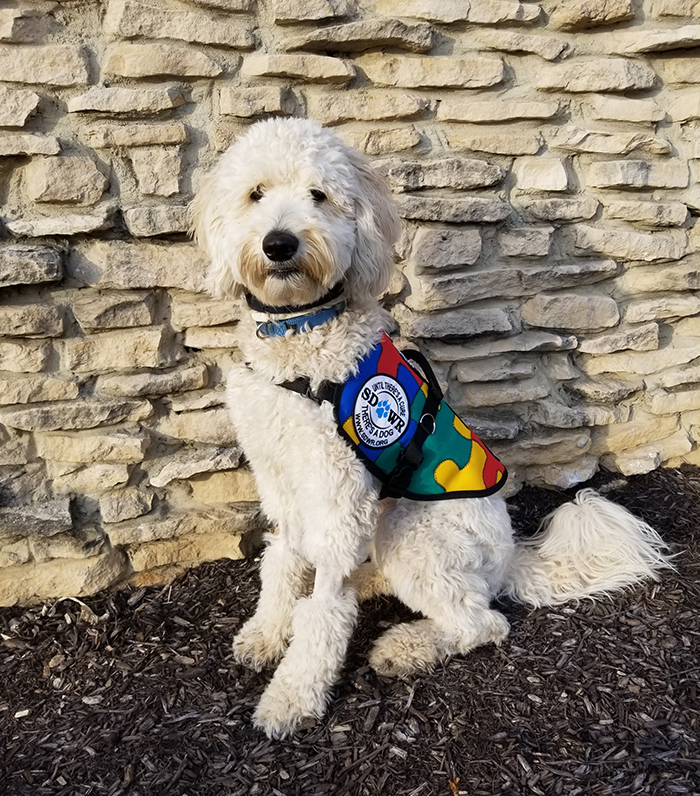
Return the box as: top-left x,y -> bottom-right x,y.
73,240 -> 206,293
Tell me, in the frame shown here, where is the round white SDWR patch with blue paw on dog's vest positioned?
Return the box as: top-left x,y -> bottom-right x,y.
353,374 -> 410,448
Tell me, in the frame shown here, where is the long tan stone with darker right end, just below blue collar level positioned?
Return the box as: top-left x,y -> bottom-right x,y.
62,328 -> 181,373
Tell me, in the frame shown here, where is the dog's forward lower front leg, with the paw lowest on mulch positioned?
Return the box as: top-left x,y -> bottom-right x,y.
253,566 -> 357,738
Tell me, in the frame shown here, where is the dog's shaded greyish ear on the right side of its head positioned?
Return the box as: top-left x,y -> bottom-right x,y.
346,149 -> 401,298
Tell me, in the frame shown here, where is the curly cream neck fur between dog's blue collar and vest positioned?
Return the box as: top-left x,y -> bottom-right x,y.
240,300 -> 393,389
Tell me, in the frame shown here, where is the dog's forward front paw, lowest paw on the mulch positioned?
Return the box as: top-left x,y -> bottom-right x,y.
253,677 -> 327,739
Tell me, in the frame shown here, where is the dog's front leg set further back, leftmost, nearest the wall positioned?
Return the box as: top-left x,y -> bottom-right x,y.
233,534 -> 309,671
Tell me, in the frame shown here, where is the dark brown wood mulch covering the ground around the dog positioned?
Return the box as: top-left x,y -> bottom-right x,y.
0,467 -> 700,796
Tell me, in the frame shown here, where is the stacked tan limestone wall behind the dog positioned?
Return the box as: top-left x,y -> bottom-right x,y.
0,0 -> 700,604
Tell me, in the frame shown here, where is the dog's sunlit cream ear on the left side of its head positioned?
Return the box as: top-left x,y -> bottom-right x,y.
190,166 -> 243,298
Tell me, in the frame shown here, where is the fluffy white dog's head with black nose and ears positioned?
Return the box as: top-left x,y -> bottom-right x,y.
193,119 -> 401,306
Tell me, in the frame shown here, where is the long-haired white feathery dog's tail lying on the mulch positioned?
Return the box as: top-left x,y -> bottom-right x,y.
503,489 -> 673,607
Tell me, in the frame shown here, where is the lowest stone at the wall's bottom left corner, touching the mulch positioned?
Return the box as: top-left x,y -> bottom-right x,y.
0,550 -> 128,606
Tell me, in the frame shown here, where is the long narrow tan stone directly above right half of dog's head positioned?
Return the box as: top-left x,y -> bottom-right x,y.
307,89 -> 427,124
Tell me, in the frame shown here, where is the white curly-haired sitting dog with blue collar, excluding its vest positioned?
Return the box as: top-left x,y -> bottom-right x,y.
194,119 -> 669,737
